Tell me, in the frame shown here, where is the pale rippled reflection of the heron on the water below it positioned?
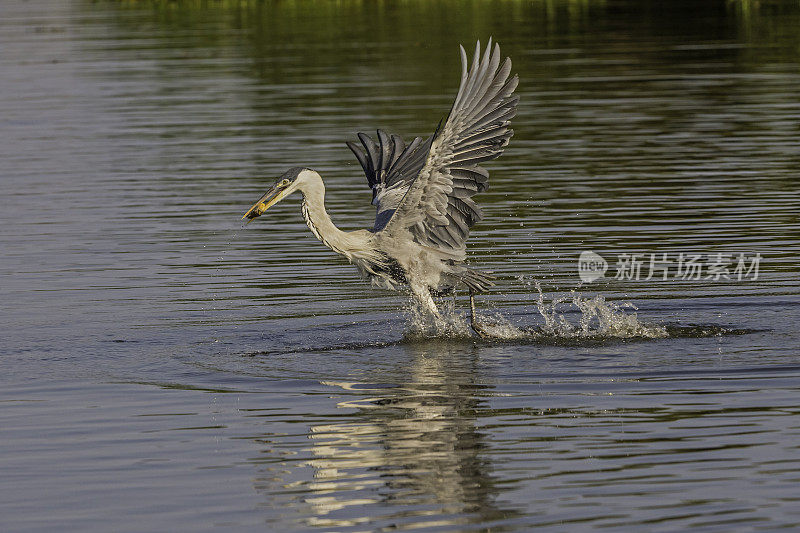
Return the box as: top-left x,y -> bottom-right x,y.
250,342 -> 515,528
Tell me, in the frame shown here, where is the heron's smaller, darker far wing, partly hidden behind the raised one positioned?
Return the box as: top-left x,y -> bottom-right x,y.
347,130 -> 433,231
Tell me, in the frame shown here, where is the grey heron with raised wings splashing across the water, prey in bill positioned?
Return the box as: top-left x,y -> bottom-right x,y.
242,38 -> 519,337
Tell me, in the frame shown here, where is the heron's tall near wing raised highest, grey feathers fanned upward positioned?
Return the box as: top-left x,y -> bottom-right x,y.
384,39 -> 519,259
